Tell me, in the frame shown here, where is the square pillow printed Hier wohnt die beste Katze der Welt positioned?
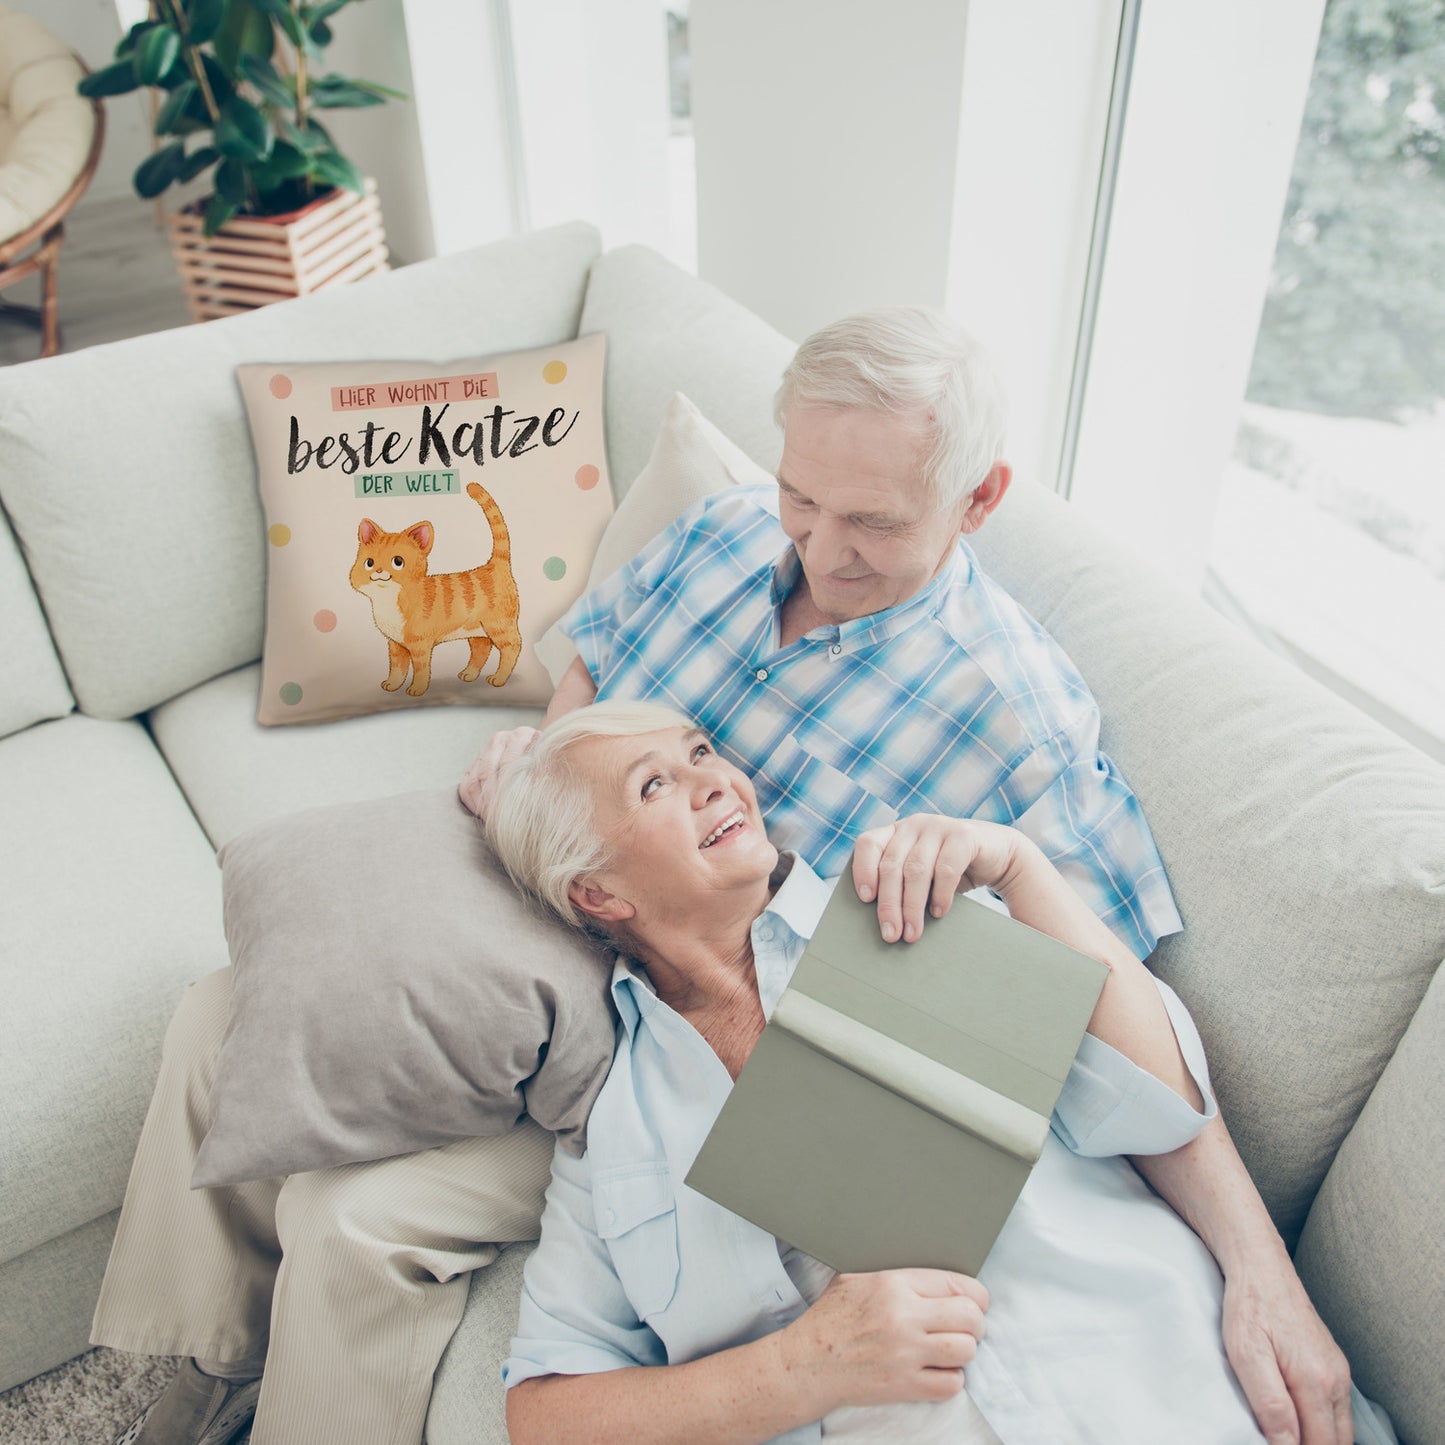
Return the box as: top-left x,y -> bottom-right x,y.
237,335 -> 613,724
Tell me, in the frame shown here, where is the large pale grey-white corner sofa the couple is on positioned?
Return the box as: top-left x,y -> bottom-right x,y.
0,225 -> 1445,1445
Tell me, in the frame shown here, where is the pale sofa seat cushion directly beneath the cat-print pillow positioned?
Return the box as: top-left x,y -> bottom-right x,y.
149,666 -> 542,848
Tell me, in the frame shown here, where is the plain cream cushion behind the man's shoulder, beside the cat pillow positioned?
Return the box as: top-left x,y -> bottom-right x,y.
538,392 -> 773,682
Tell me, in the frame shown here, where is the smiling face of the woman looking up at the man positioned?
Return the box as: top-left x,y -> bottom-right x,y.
569,727 -> 777,923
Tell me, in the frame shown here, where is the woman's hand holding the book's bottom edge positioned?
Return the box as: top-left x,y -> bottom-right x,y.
779,1269 -> 988,1413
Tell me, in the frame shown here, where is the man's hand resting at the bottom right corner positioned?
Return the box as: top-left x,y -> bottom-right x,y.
1224,1261 -> 1354,1445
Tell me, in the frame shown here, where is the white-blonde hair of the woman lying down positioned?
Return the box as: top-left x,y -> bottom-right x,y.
487,702 -> 694,931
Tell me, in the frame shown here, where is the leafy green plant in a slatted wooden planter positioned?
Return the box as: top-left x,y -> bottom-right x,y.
79,0 -> 405,319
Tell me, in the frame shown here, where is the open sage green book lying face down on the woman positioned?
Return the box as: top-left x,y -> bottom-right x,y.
686,876 -> 1108,1274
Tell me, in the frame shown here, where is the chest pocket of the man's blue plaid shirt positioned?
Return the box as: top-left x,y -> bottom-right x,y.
760,733 -> 897,877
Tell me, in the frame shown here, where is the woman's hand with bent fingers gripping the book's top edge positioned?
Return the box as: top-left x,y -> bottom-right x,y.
853,814 -> 1036,944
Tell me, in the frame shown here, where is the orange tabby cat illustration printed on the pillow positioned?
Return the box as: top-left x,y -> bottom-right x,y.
351,483 -> 522,698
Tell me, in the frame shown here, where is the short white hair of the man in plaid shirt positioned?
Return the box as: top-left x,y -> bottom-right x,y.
773,306 -> 1006,507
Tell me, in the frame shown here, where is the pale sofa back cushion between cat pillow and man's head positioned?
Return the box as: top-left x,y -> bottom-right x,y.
582,246 -> 795,500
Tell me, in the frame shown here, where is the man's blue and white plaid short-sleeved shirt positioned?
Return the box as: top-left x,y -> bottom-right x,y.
561,487 -> 1182,958
